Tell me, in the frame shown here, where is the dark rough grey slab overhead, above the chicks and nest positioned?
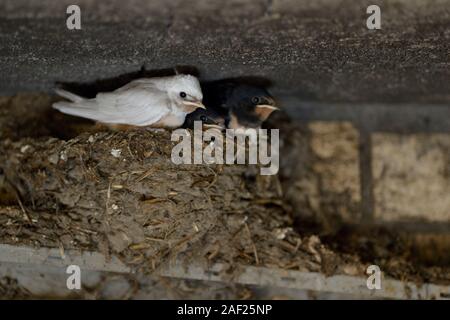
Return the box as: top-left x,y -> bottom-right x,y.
0,0 -> 450,103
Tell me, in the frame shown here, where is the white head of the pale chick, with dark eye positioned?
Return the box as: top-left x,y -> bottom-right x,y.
167,74 -> 205,113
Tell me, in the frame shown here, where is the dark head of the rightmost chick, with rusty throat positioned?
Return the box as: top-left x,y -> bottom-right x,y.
227,84 -> 278,129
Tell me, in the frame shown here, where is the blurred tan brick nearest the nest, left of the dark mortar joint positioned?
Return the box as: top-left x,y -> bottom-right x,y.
286,121 -> 361,230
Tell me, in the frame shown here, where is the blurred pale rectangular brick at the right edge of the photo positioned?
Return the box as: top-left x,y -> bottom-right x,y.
372,133 -> 450,222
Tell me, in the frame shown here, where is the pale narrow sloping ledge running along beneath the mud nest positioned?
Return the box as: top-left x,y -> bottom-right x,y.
0,245 -> 450,299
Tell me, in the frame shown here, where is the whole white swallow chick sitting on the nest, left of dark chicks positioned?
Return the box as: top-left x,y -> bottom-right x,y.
53,74 -> 205,129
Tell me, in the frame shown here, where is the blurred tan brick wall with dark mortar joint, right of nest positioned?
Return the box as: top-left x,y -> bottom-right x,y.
287,120 -> 450,232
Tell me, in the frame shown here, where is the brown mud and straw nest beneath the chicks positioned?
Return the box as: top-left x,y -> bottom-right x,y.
0,95 -> 450,283
